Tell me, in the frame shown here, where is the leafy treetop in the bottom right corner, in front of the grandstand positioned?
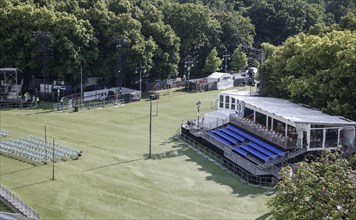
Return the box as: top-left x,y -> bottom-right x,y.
269,152 -> 356,219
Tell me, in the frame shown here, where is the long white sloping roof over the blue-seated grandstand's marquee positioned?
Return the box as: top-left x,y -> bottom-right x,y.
220,91 -> 356,126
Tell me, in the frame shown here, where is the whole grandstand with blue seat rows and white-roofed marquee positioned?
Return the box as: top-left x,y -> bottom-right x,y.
181,90 -> 356,185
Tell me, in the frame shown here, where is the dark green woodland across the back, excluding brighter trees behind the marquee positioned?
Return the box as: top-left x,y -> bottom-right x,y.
0,0 -> 355,85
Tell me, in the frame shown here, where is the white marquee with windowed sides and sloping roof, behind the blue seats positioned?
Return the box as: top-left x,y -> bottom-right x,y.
214,90 -> 356,151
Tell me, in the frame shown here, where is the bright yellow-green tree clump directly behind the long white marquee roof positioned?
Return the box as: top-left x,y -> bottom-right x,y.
264,31 -> 356,119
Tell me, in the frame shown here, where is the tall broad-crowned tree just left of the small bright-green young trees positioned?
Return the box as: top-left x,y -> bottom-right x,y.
162,3 -> 221,75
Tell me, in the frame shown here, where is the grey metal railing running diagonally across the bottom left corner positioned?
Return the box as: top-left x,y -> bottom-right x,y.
0,185 -> 41,220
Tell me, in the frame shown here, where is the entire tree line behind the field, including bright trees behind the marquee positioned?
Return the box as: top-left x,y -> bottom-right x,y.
0,0 -> 356,119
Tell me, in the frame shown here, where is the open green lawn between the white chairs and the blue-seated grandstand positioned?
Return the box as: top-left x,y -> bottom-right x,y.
0,90 -> 271,219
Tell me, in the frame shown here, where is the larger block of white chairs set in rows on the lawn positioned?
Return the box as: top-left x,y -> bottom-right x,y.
0,136 -> 80,162
